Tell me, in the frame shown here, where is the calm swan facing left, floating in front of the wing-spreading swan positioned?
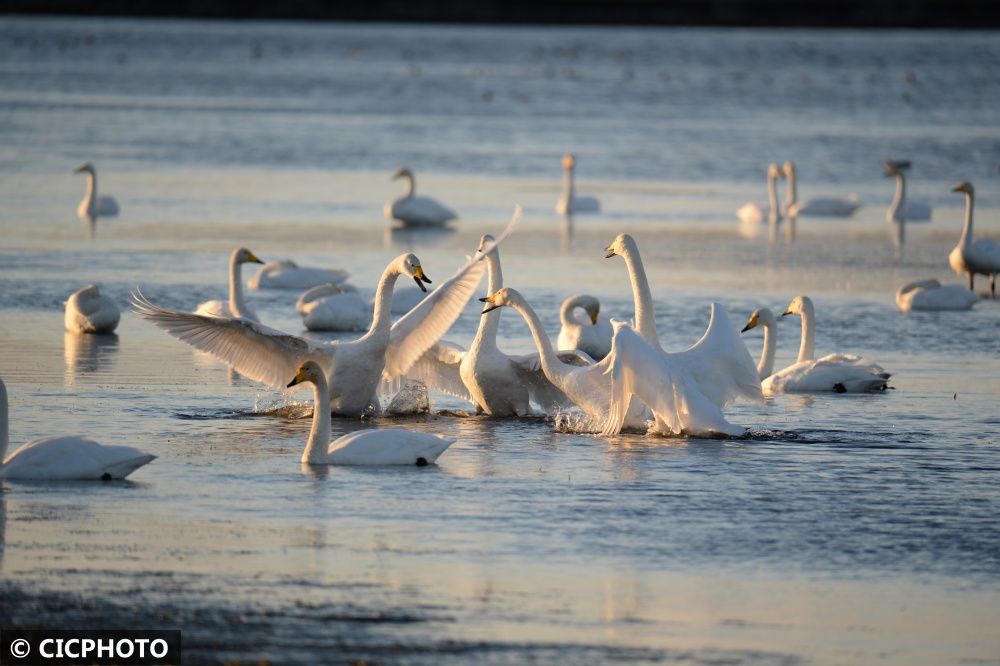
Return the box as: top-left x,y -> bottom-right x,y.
288,361 -> 455,466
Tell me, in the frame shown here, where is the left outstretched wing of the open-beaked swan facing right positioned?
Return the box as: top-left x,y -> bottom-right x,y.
132,291 -> 336,388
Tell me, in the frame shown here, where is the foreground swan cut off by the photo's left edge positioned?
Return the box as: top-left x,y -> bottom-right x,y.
0,379 -> 156,481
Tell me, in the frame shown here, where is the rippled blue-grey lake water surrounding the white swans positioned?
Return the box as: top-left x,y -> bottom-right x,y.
0,18 -> 1000,664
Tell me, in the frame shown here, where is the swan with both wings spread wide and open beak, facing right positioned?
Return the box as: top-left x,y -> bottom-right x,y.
132,210 -> 518,416
